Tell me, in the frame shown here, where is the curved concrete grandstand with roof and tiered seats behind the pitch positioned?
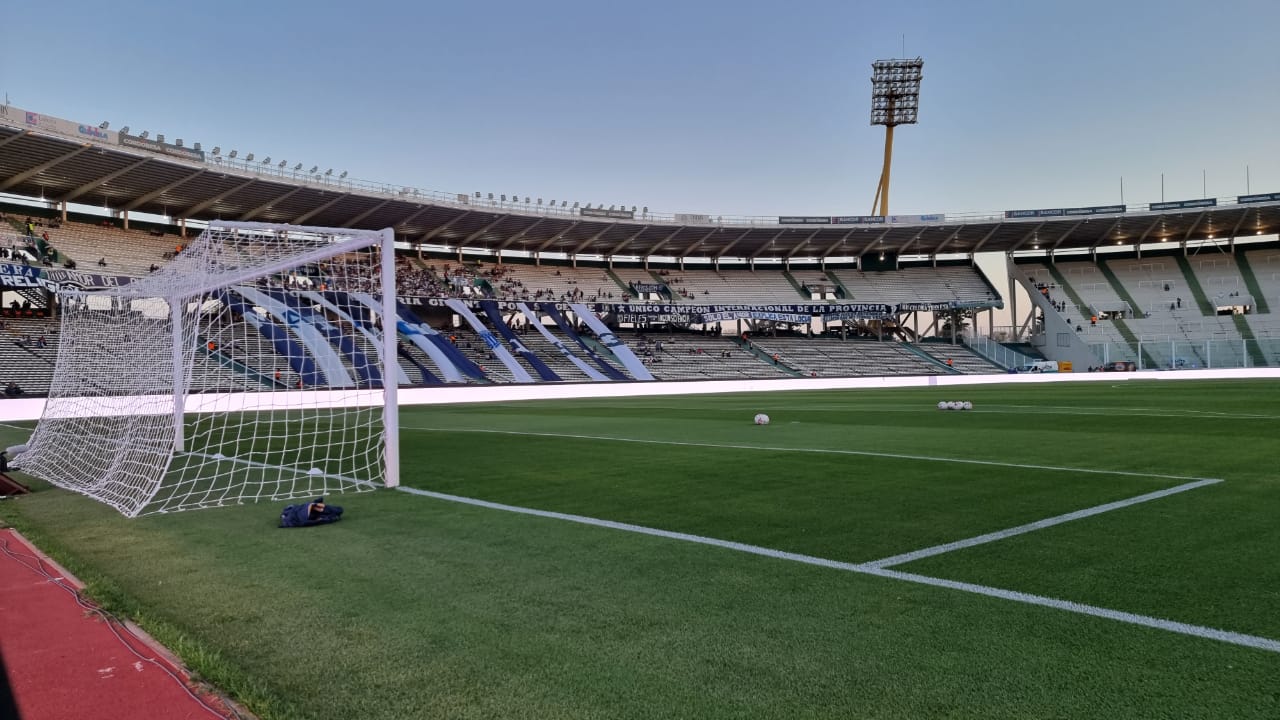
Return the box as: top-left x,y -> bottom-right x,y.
0,108 -> 1280,395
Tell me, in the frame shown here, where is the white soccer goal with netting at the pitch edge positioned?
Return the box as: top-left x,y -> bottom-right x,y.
15,222 -> 406,518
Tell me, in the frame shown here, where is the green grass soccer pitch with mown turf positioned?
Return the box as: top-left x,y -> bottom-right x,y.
0,380 -> 1280,719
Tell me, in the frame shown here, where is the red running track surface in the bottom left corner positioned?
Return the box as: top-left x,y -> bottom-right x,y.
0,529 -> 236,720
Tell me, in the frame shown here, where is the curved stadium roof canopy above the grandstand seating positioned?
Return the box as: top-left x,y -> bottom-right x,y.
0,118 -> 1280,260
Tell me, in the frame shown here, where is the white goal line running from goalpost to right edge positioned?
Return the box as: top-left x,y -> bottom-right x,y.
396,486 -> 1280,653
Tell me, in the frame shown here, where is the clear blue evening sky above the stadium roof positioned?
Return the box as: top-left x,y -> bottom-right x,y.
0,0 -> 1280,215
